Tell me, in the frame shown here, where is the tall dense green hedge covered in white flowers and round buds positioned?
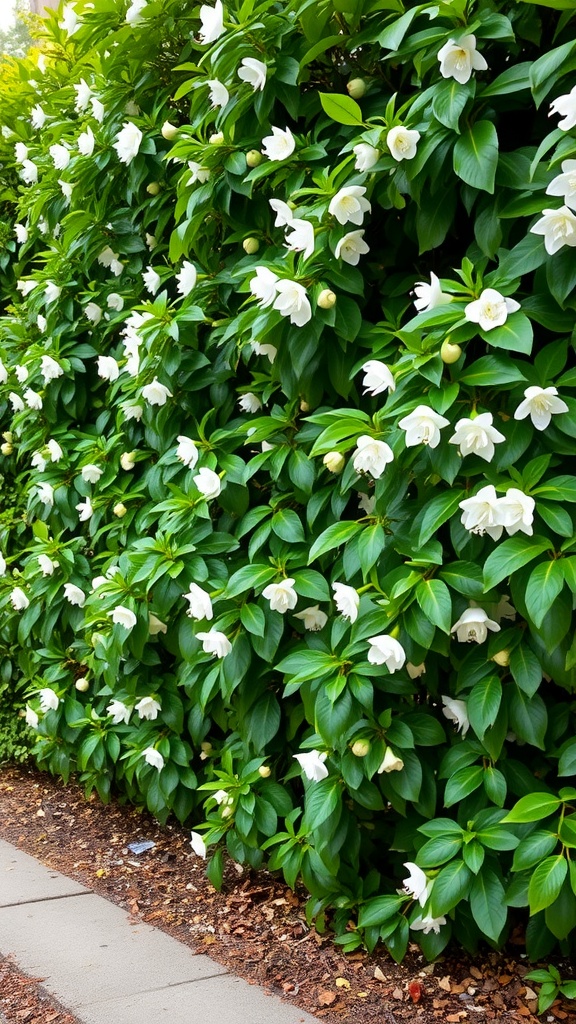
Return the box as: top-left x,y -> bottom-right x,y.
0,0 -> 576,959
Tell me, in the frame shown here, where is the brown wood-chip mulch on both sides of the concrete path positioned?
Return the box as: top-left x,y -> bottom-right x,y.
0,766 -> 576,1024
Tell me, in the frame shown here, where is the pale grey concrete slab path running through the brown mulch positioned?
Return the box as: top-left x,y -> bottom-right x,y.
0,840 -> 317,1024
